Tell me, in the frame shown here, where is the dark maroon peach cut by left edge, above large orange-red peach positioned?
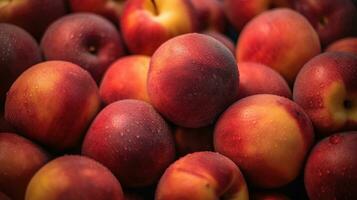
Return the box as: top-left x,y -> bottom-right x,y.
0,24 -> 41,112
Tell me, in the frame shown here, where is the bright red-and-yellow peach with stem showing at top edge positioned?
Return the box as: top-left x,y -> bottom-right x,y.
121,0 -> 198,55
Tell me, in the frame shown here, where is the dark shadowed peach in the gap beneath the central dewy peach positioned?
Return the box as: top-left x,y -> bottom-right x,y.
174,126 -> 213,156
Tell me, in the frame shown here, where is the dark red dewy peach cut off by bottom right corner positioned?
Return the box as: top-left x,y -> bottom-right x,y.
304,131 -> 357,200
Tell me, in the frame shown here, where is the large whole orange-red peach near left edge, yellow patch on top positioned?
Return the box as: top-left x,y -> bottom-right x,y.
5,61 -> 100,151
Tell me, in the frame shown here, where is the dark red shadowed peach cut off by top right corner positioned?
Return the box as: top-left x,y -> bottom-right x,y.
294,0 -> 357,46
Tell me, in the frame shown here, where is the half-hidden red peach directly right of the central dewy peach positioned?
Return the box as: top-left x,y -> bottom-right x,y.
238,62 -> 292,99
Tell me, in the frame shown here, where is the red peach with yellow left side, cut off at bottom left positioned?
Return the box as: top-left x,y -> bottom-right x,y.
25,155 -> 124,200
